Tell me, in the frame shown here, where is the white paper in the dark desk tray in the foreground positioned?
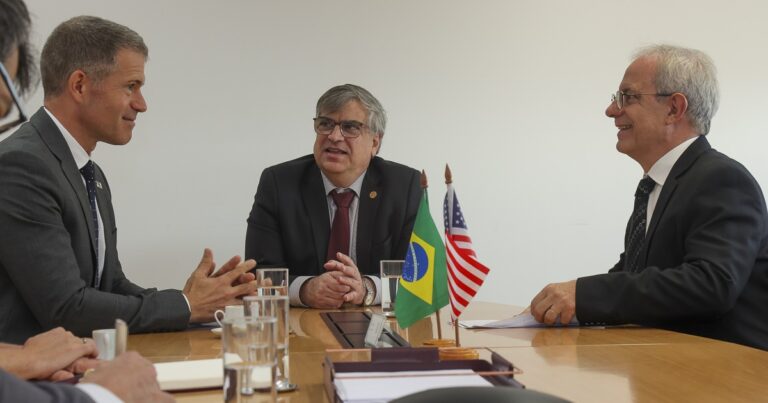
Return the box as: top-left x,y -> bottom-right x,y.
333,369 -> 493,403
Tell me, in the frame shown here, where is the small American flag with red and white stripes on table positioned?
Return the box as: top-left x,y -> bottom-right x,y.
443,183 -> 490,319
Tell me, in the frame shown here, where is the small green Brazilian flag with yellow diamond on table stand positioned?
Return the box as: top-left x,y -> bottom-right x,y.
395,188 -> 448,329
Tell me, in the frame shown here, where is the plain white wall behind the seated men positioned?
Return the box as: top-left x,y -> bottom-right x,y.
10,0 -> 768,305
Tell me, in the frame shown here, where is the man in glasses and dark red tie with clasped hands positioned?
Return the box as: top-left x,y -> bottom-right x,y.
245,84 -> 421,308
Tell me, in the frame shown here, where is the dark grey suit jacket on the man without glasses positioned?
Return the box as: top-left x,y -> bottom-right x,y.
0,108 -> 190,343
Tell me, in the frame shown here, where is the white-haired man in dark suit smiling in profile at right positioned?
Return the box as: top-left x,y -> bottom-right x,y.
531,45 -> 768,349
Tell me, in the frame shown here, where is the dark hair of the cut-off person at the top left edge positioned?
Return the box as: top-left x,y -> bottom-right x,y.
0,0 -> 37,95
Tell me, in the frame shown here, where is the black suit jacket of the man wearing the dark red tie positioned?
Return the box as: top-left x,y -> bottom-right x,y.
245,155 -> 422,280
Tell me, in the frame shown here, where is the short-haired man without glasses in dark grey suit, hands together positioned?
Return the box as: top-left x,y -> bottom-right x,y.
0,16 -> 255,343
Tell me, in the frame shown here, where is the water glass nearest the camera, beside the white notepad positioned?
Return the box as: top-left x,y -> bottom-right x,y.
221,317 -> 277,403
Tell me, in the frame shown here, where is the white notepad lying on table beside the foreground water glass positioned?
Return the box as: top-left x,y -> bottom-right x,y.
155,358 -> 224,391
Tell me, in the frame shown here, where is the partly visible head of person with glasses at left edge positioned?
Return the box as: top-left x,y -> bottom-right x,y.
0,1 -> 35,135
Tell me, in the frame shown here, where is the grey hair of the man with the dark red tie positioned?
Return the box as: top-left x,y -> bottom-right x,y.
316,84 -> 387,136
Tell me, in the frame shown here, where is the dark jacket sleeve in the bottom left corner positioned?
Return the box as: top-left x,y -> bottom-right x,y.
0,369 -> 93,403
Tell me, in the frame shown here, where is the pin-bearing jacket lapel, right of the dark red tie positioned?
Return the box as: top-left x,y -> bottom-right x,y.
356,158 -> 381,268
